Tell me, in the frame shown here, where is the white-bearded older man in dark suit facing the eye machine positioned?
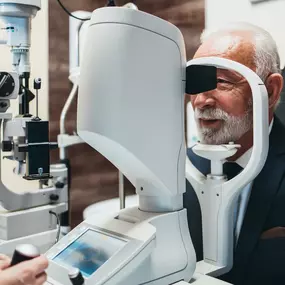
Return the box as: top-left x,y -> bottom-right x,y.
184,23 -> 285,285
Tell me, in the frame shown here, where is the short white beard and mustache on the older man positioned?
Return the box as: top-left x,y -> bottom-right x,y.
195,101 -> 253,145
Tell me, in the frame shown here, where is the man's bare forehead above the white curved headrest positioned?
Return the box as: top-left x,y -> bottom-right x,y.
194,32 -> 256,71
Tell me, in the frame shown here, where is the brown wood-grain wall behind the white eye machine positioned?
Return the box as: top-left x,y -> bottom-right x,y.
49,0 -> 204,226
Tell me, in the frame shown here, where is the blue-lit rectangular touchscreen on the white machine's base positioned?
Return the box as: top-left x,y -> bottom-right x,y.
53,227 -> 127,277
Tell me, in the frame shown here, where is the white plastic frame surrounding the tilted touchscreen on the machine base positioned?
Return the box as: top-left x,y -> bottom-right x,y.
45,218 -> 155,285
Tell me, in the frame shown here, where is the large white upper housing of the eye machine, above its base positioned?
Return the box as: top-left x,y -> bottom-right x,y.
77,7 -> 186,211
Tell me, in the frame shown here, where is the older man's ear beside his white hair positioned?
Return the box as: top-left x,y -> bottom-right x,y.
265,73 -> 284,108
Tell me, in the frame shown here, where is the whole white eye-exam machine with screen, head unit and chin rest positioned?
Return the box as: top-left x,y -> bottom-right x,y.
0,1 -> 268,285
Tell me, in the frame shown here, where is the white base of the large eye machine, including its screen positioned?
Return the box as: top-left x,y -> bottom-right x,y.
46,207 -> 196,285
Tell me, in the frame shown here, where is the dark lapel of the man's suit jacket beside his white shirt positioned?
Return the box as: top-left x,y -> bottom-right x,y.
233,118 -> 285,278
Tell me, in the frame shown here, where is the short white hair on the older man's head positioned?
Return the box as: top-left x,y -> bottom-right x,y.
201,22 -> 281,81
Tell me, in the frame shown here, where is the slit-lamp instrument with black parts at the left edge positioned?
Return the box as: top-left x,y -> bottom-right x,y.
0,0 -> 67,255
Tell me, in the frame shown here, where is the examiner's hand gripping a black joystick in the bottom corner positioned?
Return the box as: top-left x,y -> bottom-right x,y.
0,255 -> 48,285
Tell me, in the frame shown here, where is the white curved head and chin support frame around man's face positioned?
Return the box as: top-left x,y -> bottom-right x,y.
186,57 -> 269,276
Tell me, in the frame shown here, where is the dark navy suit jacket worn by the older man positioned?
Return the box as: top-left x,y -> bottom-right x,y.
184,117 -> 285,285
